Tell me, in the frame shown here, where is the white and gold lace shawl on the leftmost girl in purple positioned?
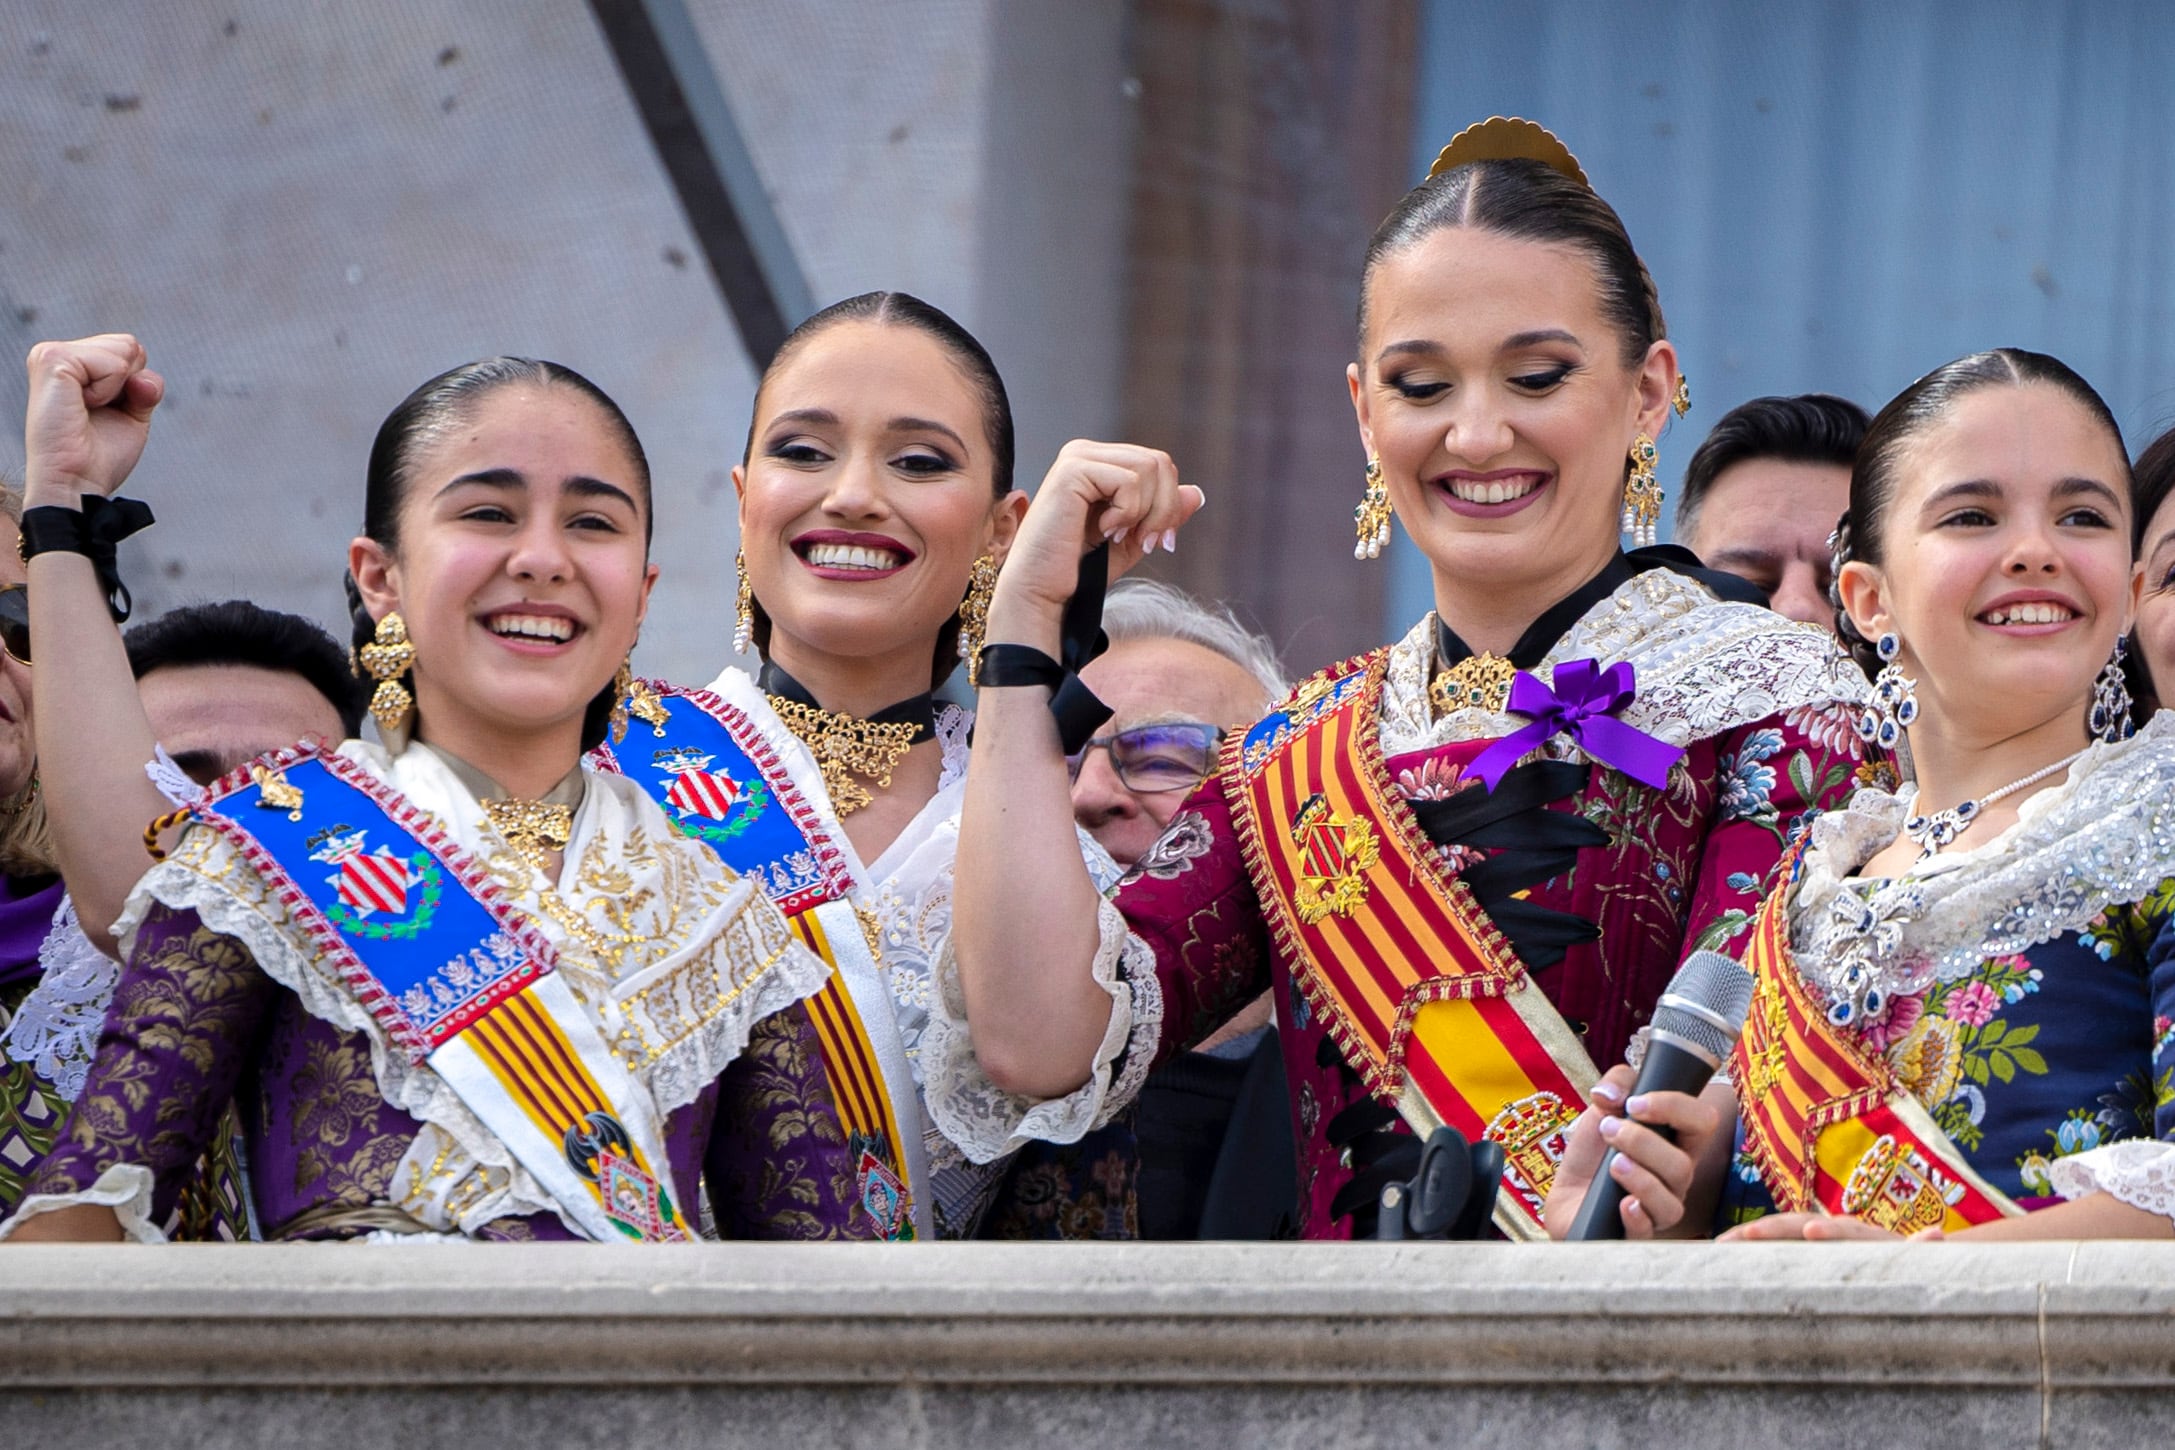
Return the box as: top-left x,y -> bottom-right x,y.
11,741 -> 827,1239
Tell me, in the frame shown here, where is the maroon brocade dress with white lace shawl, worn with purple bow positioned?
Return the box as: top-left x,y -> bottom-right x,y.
1116,557 -> 1864,1239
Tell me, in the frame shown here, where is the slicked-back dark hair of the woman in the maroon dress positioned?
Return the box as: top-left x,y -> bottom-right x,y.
1359,159 -> 1668,367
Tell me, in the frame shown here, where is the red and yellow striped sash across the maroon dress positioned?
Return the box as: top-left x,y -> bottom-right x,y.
1235,650 -> 1599,1237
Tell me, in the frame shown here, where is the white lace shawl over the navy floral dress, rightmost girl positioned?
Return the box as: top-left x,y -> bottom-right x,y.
1790,715 -> 2175,1220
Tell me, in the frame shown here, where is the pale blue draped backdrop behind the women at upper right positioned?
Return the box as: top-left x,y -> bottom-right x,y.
1388,0 -> 2175,628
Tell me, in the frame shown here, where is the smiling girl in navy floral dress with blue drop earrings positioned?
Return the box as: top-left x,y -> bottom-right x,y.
1549,350 -> 2175,1239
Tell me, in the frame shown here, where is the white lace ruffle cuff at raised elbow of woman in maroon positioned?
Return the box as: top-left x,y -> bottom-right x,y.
922,902 -> 1164,1163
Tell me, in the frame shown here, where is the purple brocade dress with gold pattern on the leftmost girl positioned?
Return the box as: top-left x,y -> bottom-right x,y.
26,907 -> 874,1239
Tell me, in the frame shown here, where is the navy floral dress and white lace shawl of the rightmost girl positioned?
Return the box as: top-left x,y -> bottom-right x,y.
1740,715 -> 2175,1217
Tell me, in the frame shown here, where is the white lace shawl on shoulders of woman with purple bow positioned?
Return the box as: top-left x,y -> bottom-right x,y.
1381,570 -> 1866,754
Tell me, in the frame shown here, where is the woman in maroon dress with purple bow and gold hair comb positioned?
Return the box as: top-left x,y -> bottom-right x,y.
950,120 -> 1862,1237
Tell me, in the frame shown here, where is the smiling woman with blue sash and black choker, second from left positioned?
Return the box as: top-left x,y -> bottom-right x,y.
602,291 -> 1168,1237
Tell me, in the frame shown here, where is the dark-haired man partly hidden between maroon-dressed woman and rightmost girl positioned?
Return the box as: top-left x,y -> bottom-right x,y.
1677,393 -> 1866,630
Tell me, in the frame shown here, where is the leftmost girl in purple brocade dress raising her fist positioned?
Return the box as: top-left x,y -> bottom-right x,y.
0,335 -> 863,1243
